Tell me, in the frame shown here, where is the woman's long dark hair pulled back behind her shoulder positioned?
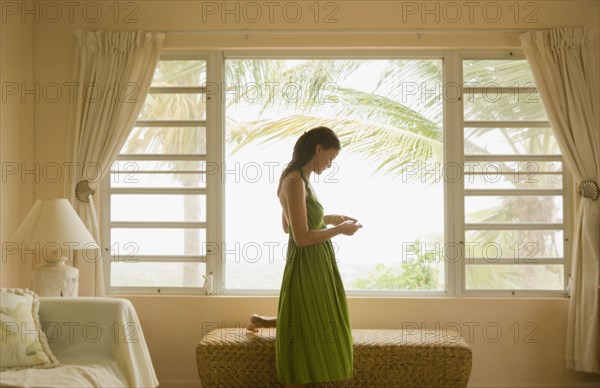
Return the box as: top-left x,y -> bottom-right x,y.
277,127 -> 342,195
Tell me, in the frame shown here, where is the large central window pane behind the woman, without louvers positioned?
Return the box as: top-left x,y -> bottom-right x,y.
224,58 -> 445,294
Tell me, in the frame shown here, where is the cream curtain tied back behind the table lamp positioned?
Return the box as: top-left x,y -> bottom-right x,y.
65,31 -> 164,296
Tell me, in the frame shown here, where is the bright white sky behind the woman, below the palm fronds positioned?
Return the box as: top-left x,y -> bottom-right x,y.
225,139 -> 444,288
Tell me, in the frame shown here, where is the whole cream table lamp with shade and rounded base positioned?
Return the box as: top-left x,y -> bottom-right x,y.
11,198 -> 100,296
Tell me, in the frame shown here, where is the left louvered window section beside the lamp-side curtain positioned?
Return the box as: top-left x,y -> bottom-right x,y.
108,58 -> 207,292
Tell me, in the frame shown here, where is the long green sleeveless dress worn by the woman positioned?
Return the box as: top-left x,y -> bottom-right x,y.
275,173 -> 352,384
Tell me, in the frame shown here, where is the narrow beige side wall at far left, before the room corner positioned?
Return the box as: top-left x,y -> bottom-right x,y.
0,7 -> 34,287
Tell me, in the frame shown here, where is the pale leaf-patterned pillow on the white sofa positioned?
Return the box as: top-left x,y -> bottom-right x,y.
0,288 -> 58,371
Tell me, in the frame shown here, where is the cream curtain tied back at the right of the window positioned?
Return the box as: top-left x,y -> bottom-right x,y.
520,28 -> 600,373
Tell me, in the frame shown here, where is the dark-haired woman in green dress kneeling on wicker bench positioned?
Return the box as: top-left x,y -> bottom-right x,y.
248,127 -> 362,385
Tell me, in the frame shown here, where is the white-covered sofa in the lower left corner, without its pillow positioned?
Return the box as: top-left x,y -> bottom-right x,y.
0,297 -> 158,388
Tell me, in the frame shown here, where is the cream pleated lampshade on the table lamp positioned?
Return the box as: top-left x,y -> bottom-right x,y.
11,198 -> 100,249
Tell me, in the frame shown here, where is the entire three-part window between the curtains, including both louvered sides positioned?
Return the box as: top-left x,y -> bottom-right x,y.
106,51 -> 568,296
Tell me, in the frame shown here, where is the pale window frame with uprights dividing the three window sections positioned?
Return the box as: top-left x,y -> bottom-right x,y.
102,49 -> 573,297
